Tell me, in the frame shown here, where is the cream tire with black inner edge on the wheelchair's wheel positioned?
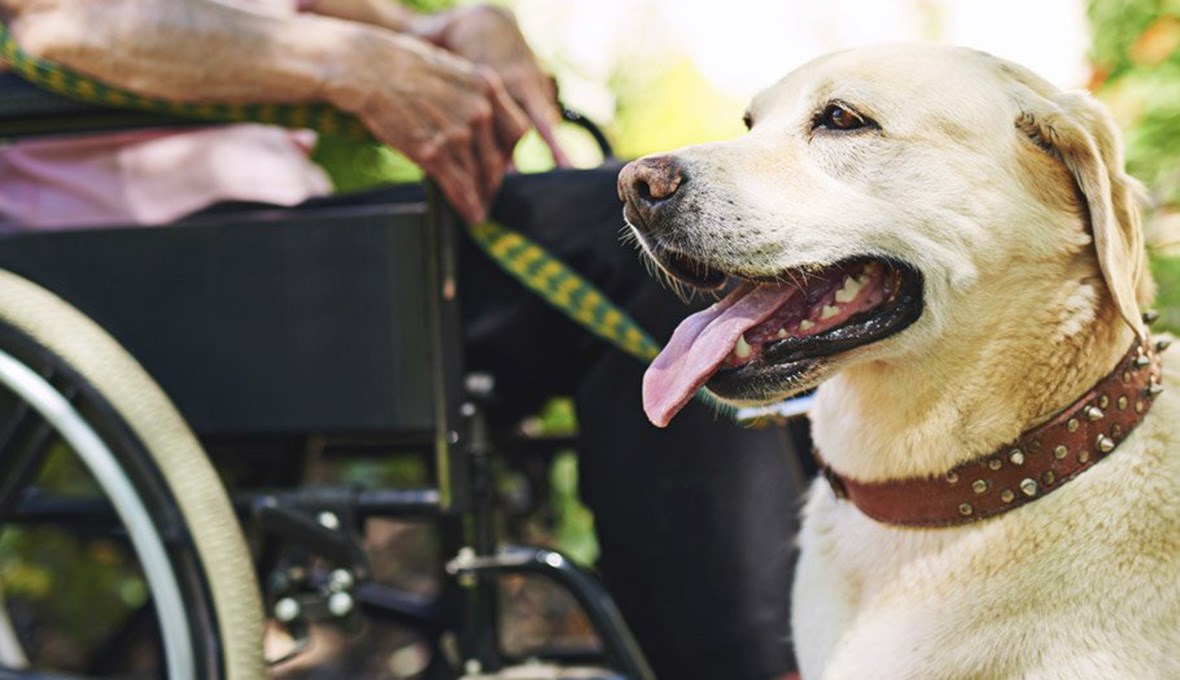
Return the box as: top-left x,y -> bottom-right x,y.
0,270 -> 266,680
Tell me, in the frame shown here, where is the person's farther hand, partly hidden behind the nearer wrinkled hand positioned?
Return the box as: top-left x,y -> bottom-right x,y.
415,5 -> 570,168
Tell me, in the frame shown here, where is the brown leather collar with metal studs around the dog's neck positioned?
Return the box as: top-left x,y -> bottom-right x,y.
815,341 -> 1167,527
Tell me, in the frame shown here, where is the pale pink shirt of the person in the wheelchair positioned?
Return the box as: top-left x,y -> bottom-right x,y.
0,0 -> 332,229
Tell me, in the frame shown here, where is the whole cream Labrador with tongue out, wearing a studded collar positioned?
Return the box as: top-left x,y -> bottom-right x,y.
620,45 -> 1180,680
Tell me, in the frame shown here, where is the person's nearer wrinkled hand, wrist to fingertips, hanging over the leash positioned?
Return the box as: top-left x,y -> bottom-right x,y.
326,35 -> 529,222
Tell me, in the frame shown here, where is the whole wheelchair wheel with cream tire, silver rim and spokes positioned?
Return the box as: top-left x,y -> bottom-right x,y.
0,272 -> 266,679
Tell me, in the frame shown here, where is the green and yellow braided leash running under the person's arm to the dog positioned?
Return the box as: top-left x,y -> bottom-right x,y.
0,25 -> 674,361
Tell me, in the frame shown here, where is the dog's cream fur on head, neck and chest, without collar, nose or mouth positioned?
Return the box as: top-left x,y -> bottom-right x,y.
637,45 -> 1180,680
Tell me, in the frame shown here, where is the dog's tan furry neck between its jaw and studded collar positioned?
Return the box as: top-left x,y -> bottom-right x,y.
813,277 -> 1133,482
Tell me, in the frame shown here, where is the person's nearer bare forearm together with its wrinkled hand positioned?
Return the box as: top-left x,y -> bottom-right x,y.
0,0 -> 527,220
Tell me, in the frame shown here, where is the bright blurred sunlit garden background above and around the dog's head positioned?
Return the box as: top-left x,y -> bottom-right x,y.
337,0 -> 1180,233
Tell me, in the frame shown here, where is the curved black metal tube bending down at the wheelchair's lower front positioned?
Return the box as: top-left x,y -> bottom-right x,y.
447,547 -> 656,680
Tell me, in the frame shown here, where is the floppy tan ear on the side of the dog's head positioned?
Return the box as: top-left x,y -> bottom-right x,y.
1016,89 -> 1154,339
